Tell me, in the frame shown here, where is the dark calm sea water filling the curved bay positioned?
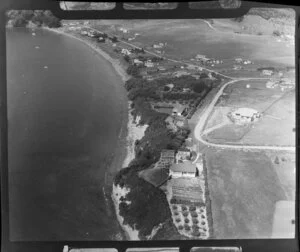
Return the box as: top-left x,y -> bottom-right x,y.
7,29 -> 128,241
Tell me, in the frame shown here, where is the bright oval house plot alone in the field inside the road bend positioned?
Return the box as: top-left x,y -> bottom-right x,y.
229,108 -> 261,124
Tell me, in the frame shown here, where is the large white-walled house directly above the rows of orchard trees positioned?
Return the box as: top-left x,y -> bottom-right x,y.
169,161 -> 199,178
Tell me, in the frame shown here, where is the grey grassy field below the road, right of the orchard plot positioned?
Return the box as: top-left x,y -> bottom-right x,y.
206,150 -> 286,239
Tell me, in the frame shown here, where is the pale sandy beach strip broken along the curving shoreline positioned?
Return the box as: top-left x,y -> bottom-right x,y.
46,28 -> 148,240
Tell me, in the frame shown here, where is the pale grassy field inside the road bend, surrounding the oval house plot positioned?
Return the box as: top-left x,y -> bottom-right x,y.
206,80 -> 296,146
